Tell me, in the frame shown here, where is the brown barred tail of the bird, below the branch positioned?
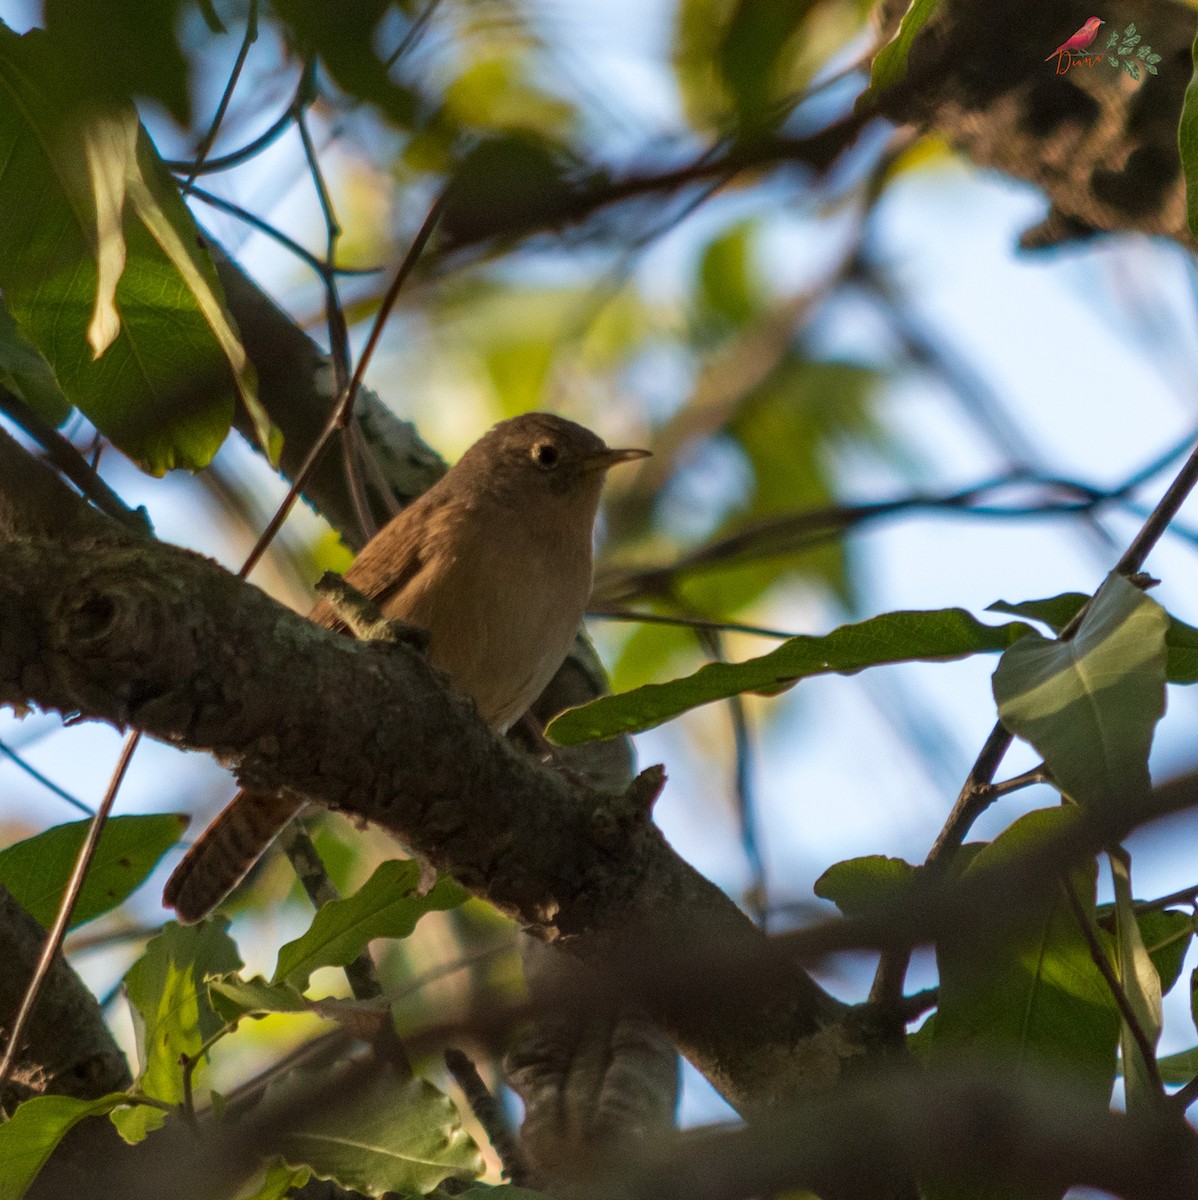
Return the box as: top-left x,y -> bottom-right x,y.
162,792 -> 304,925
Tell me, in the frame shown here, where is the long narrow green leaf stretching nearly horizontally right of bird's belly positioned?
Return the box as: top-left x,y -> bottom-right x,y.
546,608 -> 1031,745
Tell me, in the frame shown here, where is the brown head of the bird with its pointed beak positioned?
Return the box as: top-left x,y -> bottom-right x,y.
454,413 -> 649,503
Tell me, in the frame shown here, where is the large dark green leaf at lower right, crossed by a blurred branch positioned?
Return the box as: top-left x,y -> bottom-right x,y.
933,805 -> 1119,1105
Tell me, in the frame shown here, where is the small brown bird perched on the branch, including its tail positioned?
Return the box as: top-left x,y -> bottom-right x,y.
162,413 -> 648,922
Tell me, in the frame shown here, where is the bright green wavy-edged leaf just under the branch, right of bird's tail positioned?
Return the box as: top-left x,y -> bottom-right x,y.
272,859 -> 467,991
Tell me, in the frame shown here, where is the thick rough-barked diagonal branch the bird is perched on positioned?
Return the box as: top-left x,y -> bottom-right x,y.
0,477 -> 849,1110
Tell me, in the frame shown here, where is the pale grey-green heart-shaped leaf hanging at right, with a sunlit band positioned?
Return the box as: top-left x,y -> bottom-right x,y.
994,575 -> 1168,810
